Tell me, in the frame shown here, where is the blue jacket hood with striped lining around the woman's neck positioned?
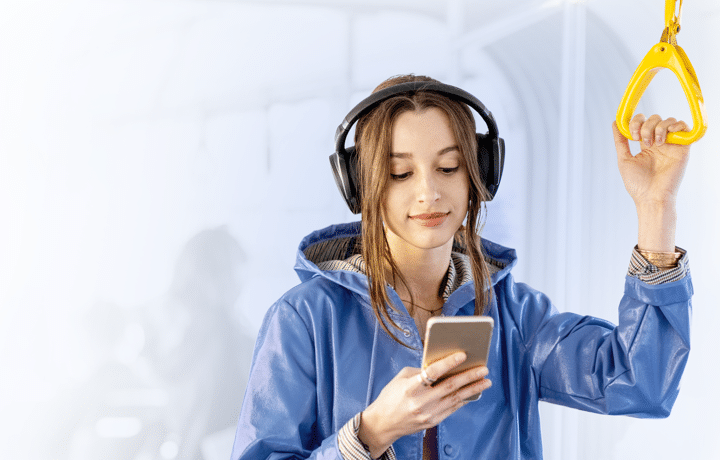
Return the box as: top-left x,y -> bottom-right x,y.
295,222 -> 517,297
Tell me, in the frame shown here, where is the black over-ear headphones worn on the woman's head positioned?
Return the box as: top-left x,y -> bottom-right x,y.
330,81 -> 505,214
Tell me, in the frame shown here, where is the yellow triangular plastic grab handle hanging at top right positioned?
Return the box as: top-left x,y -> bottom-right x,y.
615,42 -> 707,145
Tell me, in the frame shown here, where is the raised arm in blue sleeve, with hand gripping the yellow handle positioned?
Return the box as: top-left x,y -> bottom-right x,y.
528,115 -> 693,417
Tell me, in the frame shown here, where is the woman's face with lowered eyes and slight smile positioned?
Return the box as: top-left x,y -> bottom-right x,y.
383,107 -> 469,253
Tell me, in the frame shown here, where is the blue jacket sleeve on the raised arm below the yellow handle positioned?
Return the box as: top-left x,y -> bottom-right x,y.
525,255 -> 693,418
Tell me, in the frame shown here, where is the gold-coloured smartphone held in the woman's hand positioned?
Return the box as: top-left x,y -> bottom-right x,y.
422,316 -> 495,401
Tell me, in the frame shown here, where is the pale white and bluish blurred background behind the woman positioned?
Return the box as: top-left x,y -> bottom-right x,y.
0,0 -> 720,460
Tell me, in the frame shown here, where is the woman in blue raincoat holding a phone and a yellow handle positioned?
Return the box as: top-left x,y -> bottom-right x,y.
232,76 -> 692,460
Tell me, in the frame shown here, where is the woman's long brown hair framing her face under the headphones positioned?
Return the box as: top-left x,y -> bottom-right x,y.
355,75 -> 490,344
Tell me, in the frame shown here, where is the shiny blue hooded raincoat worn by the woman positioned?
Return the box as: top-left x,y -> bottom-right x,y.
232,223 -> 693,460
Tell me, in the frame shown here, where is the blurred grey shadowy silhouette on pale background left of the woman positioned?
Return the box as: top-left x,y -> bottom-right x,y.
43,227 -> 254,460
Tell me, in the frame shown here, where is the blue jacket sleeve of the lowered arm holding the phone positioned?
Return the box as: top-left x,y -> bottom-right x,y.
231,300 -> 342,460
